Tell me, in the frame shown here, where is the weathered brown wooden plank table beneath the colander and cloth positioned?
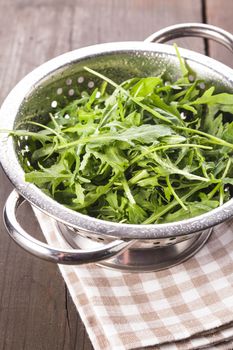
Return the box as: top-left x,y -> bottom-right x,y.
0,0 -> 233,350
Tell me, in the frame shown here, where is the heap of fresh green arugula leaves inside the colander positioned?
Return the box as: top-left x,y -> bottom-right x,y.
10,48 -> 233,224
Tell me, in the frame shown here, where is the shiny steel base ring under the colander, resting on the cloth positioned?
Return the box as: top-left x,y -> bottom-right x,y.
57,223 -> 213,272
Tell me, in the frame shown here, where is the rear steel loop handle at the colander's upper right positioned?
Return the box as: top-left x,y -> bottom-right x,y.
145,23 -> 233,51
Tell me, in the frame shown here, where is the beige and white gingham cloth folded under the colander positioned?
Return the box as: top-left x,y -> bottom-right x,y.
36,211 -> 233,350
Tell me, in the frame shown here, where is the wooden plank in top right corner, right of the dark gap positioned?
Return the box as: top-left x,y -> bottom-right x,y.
206,0 -> 233,68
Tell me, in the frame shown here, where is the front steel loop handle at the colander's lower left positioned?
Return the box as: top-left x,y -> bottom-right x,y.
3,190 -> 134,265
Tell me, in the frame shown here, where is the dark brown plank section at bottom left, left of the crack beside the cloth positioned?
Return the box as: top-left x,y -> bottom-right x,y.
0,172 -> 73,350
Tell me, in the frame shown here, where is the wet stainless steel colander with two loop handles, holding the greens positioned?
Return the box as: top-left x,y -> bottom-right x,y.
0,23 -> 233,271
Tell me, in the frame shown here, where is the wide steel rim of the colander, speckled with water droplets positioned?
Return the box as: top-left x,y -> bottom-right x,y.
0,41 -> 233,239
